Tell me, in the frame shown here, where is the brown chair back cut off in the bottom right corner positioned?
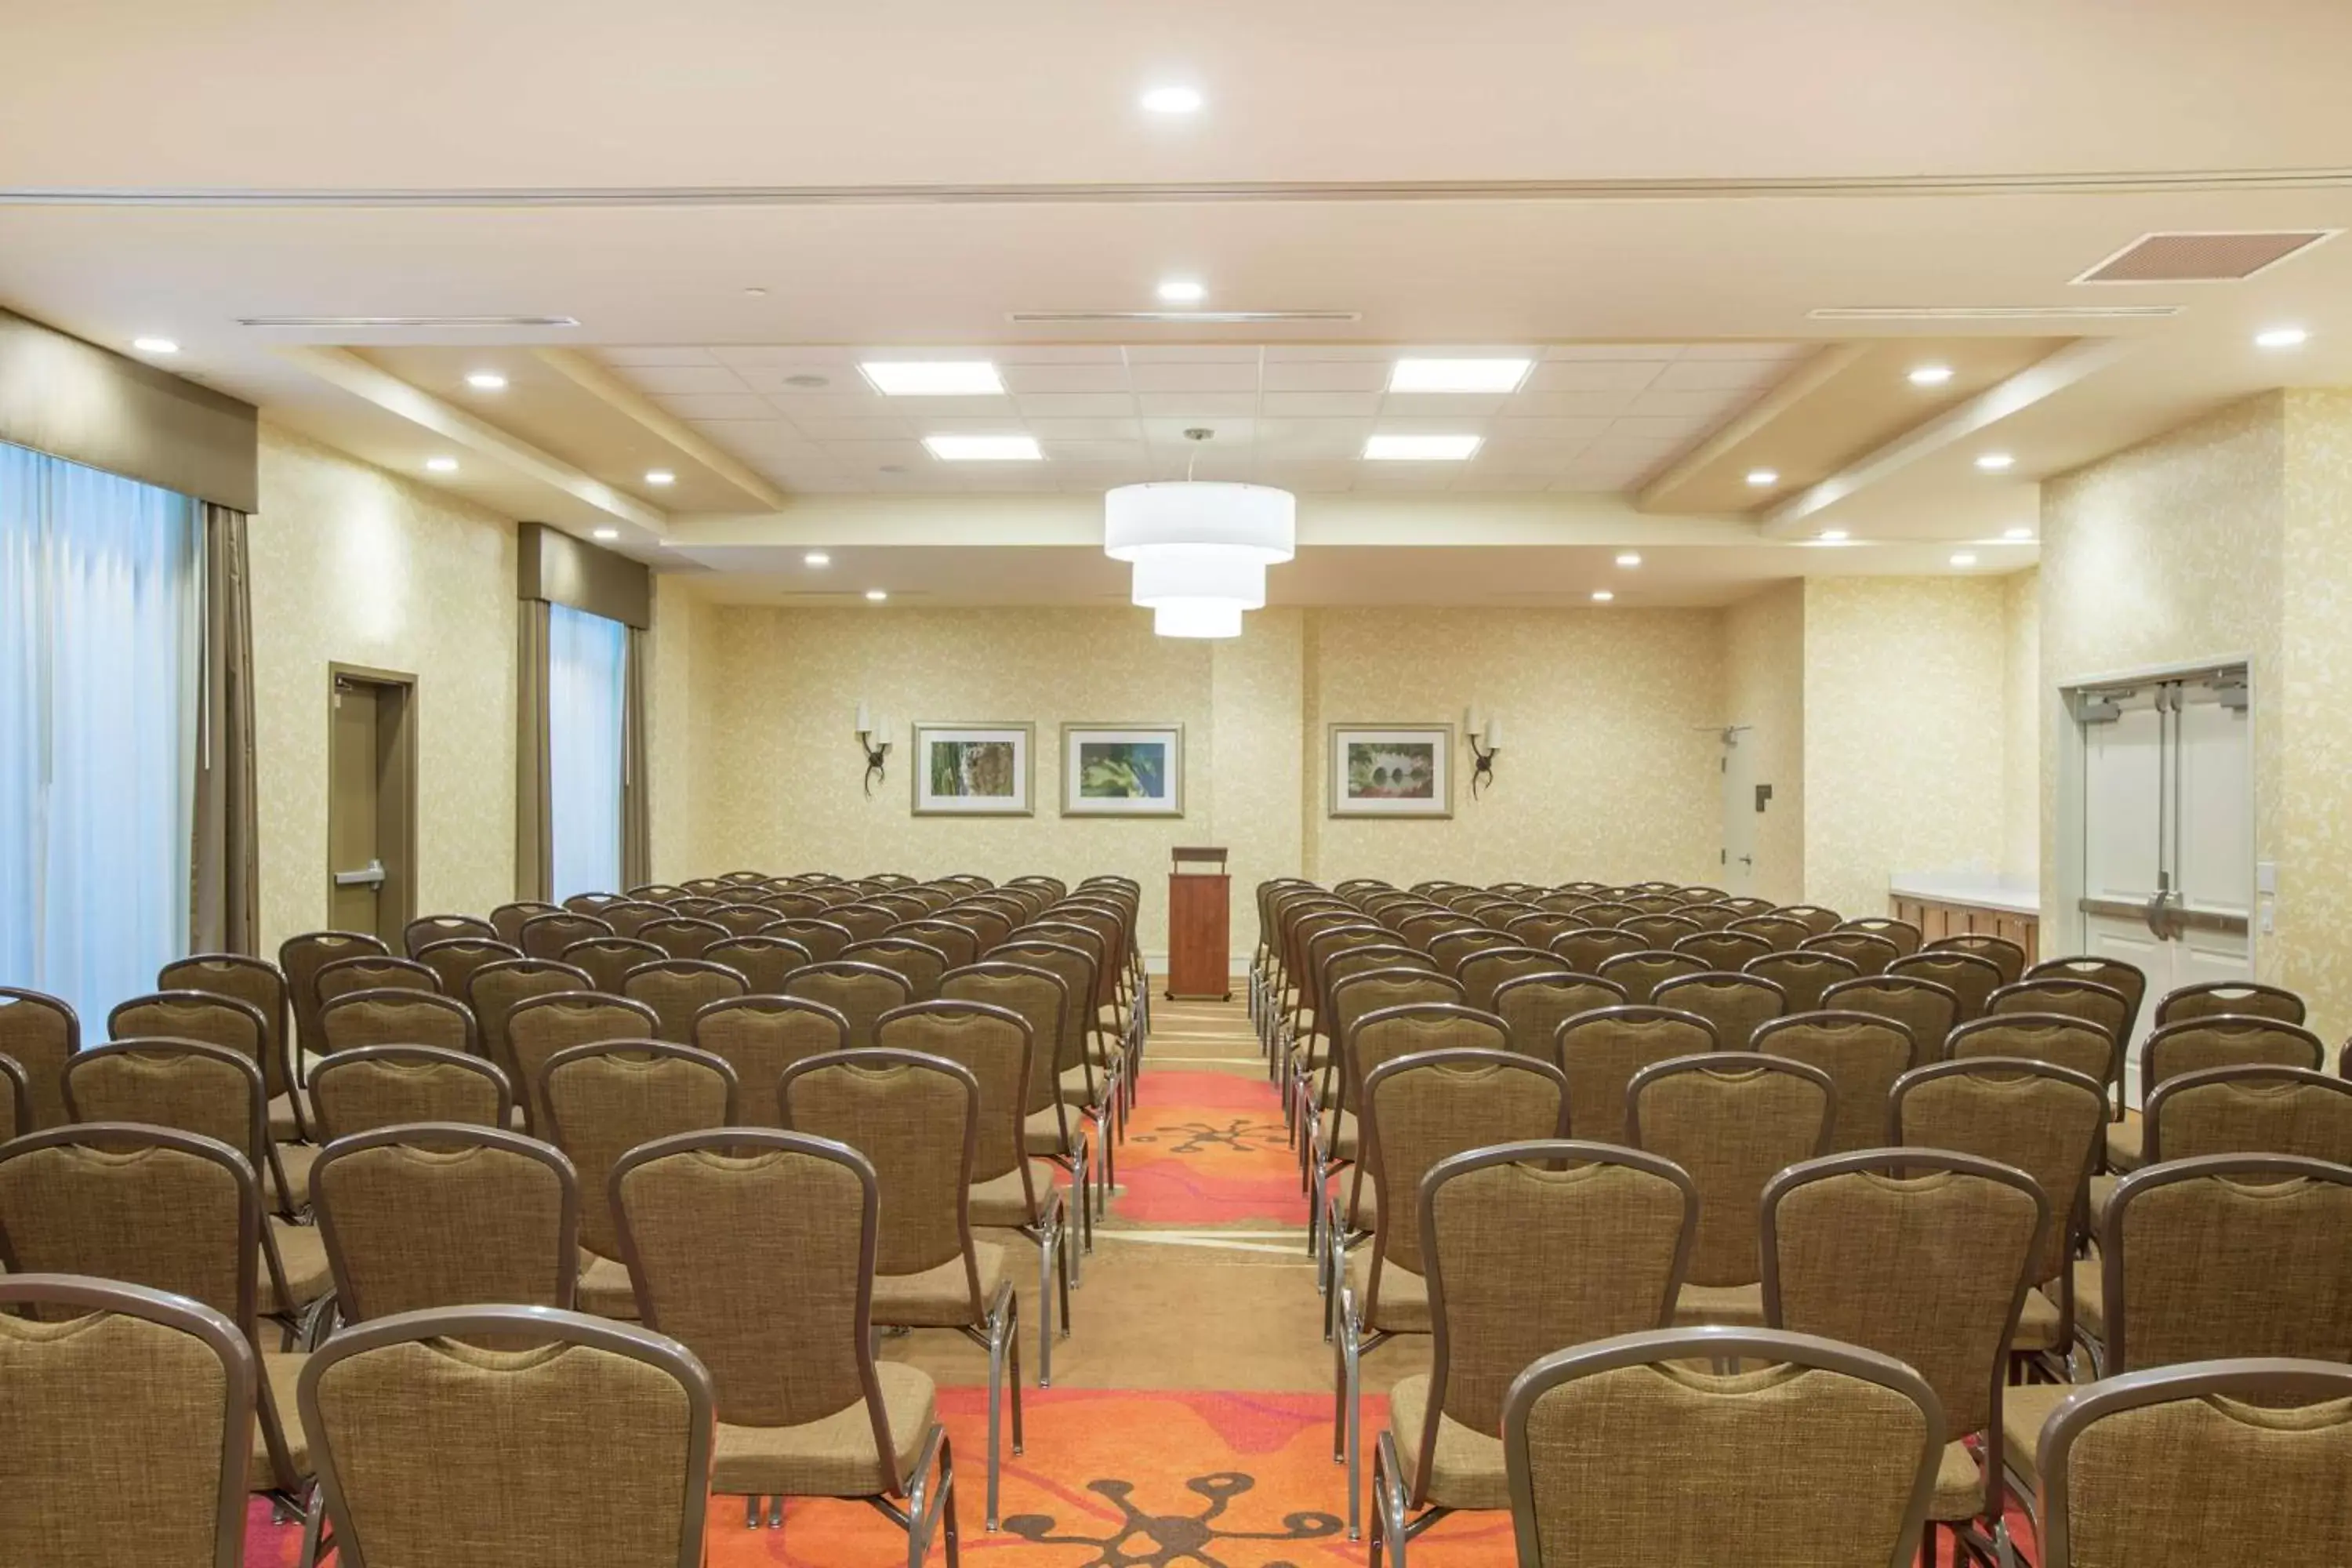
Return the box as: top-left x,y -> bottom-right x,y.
2034,1359 -> 2352,1568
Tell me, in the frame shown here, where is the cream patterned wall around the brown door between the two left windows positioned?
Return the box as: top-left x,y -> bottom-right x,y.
252,423 -> 515,952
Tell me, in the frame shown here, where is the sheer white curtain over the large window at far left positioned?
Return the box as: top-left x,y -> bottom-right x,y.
0,445 -> 202,1039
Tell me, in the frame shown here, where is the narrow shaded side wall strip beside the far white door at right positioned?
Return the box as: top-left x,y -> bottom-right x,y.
1724,581 -> 1806,902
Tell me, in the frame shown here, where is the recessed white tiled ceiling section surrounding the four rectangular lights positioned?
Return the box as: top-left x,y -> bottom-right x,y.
602,343 -> 1809,494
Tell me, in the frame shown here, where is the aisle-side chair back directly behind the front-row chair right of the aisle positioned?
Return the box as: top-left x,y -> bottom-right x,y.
1414,1140 -> 1698,1476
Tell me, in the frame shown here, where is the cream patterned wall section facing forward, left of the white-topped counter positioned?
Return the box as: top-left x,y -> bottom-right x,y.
1804,576 -> 2006,914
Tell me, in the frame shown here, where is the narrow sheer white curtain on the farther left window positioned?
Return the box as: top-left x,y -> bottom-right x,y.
548,604 -> 628,900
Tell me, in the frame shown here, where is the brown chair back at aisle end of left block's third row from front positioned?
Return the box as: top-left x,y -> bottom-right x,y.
776,1046 -> 985,1319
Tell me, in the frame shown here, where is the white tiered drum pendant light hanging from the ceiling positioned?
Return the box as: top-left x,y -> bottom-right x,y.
1103,430 -> 1298,637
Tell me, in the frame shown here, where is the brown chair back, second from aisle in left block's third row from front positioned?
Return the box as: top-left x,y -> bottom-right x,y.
539,1039 -> 736,1258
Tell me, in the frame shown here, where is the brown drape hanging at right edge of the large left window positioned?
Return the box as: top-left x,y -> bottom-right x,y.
188,501 -> 261,952
